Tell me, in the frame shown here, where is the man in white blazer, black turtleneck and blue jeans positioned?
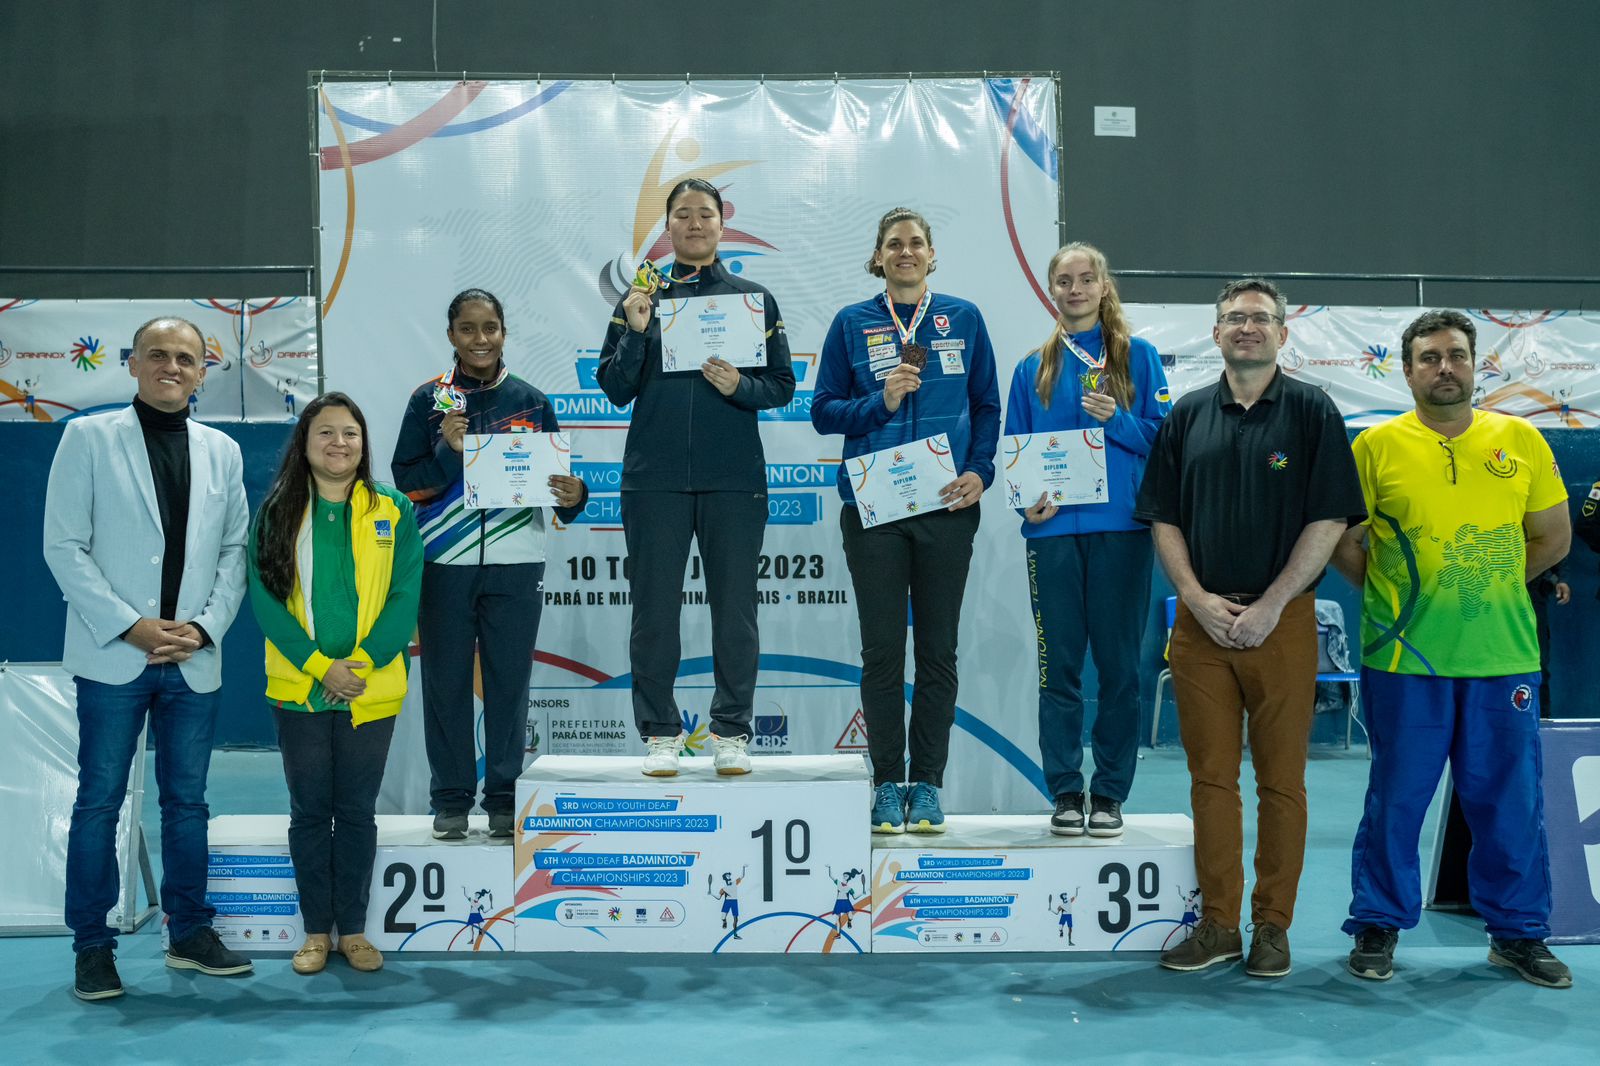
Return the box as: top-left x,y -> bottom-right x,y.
45,319 -> 251,1000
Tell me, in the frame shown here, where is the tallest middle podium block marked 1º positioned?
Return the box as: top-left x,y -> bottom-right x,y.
515,755 -> 872,954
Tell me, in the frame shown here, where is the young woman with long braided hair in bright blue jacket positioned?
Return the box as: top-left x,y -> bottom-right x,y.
1005,243 -> 1171,837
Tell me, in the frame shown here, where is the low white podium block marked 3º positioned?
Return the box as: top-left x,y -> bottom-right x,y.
872,815 -> 1200,952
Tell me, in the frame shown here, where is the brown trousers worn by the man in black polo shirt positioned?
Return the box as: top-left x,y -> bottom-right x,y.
1168,592 -> 1317,928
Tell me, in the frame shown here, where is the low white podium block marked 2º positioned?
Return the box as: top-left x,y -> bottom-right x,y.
206,815 -> 515,954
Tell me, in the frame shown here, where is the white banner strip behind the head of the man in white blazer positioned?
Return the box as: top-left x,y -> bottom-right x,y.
0,296 -> 317,423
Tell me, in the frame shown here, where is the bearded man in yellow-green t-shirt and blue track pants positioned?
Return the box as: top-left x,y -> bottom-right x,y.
1333,311 -> 1573,988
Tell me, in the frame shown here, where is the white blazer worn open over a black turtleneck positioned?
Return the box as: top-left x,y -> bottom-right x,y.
45,405 -> 250,691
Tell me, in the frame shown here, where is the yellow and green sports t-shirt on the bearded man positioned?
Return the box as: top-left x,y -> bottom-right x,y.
1354,411 -> 1566,677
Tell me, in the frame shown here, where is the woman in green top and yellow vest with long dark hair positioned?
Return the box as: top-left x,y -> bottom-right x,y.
250,392 -> 422,973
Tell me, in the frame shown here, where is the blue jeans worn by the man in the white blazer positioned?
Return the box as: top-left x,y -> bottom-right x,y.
66,663 -> 221,951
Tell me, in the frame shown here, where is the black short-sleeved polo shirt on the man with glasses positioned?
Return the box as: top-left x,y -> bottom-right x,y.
1133,370 -> 1366,595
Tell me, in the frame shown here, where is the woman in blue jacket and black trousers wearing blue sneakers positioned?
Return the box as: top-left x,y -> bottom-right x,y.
811,208 -> 1000,832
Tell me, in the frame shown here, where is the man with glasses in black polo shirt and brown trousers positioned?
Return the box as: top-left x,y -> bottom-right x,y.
1134,279 -> 1366,976
